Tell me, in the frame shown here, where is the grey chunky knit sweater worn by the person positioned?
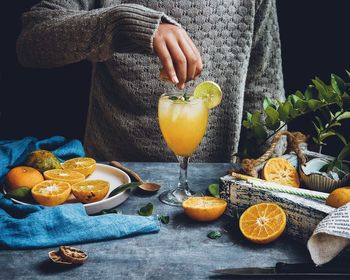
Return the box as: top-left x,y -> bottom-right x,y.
17,0 -> 284,162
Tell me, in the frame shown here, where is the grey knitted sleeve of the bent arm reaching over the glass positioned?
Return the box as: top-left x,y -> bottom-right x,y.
17,0 -> 176,67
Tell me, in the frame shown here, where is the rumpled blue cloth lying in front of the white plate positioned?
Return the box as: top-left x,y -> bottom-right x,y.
0,194 -> 160,249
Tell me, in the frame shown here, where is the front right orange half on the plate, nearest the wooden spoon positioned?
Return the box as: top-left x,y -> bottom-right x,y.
72,180 -> 109,203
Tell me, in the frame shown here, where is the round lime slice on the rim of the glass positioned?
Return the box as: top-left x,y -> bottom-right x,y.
193,81 -> 222,109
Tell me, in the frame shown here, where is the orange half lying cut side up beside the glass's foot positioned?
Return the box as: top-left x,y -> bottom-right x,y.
182,196 -> 227,222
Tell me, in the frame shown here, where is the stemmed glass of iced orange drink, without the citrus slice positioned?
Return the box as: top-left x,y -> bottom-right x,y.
158,93 -> 209,206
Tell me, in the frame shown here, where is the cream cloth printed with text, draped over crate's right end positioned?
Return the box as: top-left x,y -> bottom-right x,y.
307,203 -> 350,265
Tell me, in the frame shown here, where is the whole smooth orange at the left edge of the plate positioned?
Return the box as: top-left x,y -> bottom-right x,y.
6,166 -> 44,190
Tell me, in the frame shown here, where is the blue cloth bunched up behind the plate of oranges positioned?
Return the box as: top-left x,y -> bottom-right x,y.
0,136 -> 85,183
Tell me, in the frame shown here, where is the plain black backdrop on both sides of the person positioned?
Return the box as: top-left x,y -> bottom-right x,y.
0,0 -> 350,156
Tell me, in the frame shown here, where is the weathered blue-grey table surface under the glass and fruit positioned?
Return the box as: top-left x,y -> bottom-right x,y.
0,163 -> 330,279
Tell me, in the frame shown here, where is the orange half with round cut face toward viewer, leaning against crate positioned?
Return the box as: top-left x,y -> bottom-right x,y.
239,203 -> 287,244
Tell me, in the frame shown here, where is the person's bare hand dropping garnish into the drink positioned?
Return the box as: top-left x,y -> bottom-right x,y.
153,23 -> 203,89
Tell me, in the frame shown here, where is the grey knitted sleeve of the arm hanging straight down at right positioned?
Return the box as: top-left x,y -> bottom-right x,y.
244,0 -> 285,112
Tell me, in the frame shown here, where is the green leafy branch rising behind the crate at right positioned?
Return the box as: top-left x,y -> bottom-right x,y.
240,71 -> 350,166
